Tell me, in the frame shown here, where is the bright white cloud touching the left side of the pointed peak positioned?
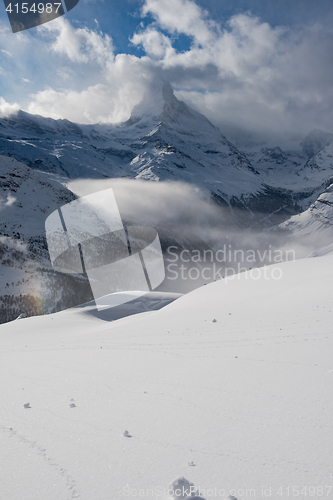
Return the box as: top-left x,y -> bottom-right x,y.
26,18 -> 149,123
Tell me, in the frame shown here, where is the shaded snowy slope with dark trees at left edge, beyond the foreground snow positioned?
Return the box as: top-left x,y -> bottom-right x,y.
0,157 -> 92,323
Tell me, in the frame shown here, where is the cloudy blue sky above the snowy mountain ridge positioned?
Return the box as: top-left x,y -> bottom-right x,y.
0,0 -> 333,137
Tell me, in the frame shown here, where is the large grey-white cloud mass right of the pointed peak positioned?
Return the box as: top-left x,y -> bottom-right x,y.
132,0 -> 333,132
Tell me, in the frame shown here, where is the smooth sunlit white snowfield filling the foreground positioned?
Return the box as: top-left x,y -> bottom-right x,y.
0,256 -> 333,500
